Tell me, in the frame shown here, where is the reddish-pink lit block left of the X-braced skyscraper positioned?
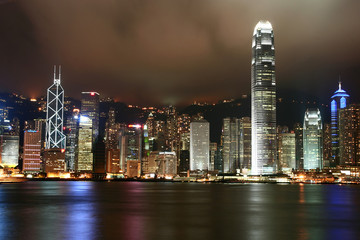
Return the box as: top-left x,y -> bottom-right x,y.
22,130 -> 41,173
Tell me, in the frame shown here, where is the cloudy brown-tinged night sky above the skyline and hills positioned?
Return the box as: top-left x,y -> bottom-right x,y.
0,0 -> 360,106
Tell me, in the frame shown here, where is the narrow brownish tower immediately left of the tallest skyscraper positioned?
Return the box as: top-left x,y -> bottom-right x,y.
239,117 -> 251,171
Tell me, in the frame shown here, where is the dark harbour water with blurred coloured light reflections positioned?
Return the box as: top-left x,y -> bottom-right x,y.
0,182 -> 360,240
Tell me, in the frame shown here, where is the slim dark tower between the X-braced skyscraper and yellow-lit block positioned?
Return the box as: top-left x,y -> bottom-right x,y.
65,108 -> 80,172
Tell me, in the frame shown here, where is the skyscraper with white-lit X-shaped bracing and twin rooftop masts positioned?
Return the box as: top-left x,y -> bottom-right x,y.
46,66 -> 66,149
